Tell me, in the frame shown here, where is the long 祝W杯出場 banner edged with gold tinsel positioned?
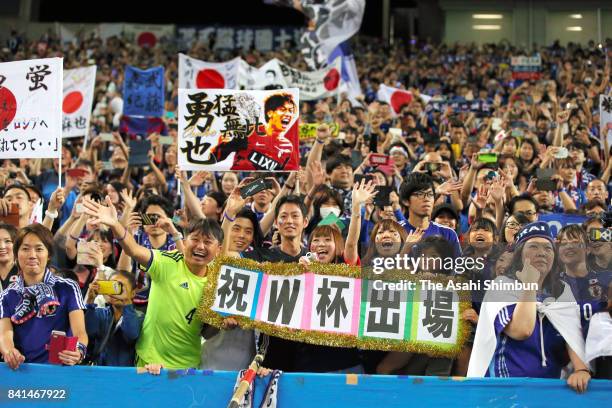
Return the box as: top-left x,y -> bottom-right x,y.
198,258 -> 471,358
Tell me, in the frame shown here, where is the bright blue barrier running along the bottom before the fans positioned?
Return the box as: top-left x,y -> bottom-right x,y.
0,363 -> 612,408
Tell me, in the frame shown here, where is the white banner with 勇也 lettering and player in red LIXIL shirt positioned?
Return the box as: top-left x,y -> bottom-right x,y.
178,88 -> 300,171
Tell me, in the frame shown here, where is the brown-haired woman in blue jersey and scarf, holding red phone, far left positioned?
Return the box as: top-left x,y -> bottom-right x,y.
0,224 -> 87,369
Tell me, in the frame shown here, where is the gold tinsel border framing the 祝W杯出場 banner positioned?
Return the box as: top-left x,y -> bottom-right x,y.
197,257 -> 472,358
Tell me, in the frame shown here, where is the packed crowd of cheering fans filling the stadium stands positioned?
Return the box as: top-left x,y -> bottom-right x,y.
0,28 -> 612,390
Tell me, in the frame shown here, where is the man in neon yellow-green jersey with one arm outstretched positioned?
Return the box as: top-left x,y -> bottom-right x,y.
84,198 -> 223,373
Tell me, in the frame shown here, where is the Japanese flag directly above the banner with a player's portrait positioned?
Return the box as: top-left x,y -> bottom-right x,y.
179,54 -> 241,89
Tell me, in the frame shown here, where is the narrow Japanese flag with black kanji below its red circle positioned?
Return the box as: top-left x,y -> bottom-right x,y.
62,65 -> 96,138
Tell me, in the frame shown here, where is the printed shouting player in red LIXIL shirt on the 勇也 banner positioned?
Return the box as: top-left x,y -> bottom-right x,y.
214,92 -> 299,171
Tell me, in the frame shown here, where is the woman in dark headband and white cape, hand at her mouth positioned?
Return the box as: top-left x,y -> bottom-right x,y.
468,222 -> 591,392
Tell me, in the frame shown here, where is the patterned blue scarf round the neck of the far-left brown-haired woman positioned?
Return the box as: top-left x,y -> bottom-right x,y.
11,269 -> 60,324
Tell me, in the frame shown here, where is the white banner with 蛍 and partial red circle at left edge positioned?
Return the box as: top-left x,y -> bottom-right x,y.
0,58 -> 63,159
